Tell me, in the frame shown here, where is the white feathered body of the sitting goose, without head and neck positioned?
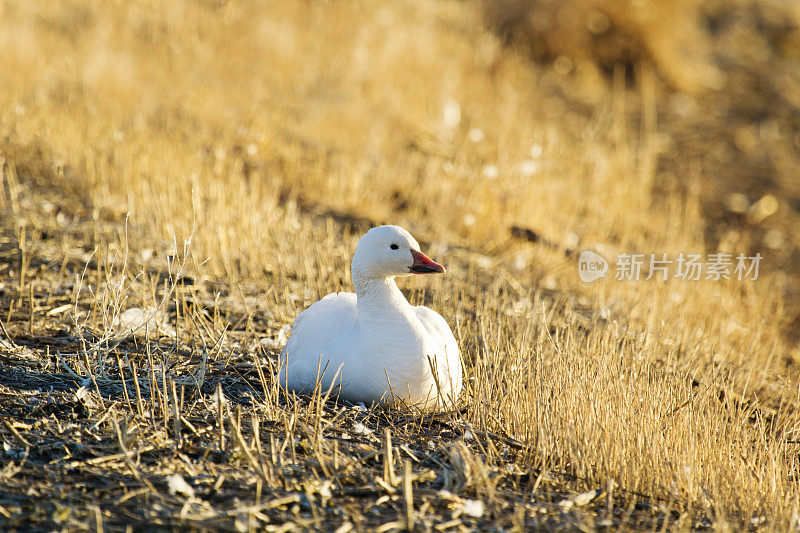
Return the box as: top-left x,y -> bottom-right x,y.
278,289 -> 462,408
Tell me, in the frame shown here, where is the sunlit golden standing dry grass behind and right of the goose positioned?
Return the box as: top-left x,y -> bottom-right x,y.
0,0 -> 800,529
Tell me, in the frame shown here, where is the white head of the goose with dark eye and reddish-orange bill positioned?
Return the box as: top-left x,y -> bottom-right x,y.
352,226 -> 445,280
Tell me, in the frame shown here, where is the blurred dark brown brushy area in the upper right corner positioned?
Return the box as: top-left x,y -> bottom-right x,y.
482,0 -> 800,341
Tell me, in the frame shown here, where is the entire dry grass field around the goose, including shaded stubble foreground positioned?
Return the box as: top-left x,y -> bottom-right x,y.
0,0 -> 800,532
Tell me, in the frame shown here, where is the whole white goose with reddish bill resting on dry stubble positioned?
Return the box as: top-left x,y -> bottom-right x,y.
278,226 -> 462,409
